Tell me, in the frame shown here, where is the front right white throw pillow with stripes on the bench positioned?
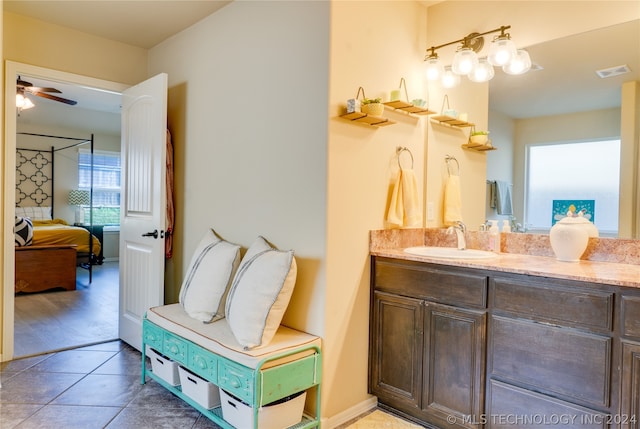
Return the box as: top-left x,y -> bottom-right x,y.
226,237 -> 298,350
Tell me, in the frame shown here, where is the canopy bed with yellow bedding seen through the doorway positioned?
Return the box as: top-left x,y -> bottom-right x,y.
15,132 -> 102,292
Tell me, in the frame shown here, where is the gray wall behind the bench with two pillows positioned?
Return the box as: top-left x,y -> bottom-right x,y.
149,1 -> 331,414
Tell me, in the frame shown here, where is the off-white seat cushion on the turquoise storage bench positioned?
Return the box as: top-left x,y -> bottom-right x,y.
147,304 -> 321,369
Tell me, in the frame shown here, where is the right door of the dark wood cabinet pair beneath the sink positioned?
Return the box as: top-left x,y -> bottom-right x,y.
422,302 -> 487,427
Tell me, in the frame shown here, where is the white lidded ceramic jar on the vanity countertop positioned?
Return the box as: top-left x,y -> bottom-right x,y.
549,216 -> 598,262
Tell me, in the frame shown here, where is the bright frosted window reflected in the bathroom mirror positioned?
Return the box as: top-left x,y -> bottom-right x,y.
525,139 -> 620,235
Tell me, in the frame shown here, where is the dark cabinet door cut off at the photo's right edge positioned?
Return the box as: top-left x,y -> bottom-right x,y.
620,341 -> 640,429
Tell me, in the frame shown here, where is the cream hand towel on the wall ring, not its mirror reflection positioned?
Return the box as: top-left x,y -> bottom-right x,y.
386,168 -> 422,228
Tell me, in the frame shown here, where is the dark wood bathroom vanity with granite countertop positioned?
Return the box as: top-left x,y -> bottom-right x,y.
369,231 -> 640,428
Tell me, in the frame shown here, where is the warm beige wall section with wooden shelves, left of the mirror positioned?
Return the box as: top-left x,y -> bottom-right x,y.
323,1 -> 428,427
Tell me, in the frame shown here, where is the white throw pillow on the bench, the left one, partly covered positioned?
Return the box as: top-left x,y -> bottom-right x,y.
179,230 -> 240,323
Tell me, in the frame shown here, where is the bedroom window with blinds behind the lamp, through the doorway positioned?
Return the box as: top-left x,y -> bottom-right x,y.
78,149 -> 120,225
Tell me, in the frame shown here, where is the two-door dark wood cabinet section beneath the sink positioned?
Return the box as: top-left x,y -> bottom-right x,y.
369,258 -> 487,427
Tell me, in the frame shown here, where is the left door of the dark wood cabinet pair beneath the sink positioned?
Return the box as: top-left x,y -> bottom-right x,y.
369,292 -> 423,410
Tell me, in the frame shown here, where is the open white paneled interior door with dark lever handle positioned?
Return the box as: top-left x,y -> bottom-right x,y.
119,73 -> 167,350
